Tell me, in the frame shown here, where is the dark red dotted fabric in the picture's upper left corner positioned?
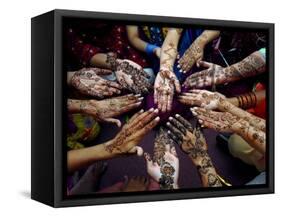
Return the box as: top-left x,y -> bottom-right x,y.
66,22 -> 148,68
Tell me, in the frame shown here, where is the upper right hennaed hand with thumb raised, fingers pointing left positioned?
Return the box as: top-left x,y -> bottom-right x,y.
183,61 -> 226,88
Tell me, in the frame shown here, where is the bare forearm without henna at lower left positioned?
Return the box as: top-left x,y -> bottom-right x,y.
67,140 -> 116,173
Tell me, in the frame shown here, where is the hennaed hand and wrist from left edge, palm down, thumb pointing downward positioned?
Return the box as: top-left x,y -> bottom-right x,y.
68,94 -> 143,127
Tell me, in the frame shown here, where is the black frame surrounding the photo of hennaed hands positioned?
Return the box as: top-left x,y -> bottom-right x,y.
31,10 -> 274,207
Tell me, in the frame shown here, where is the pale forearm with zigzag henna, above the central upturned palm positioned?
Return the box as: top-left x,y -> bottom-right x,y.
160,29 -> 181,71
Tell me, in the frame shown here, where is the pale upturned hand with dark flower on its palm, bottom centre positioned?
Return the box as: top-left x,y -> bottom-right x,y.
144,128 -> 179,190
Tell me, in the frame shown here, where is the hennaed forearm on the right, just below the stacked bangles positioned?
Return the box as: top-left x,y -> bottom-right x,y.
219,100 -> 266,132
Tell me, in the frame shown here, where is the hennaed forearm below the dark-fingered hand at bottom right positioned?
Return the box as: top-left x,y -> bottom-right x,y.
191,152 -> 222,187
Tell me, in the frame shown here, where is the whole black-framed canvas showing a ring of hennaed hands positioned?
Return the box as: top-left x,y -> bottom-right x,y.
31,10 -> 274,207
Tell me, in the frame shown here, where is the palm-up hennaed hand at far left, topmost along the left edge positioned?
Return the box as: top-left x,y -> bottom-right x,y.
68,68 -> 122,98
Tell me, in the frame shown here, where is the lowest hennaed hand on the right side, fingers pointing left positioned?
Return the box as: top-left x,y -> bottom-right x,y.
191,107 -> 243,133
